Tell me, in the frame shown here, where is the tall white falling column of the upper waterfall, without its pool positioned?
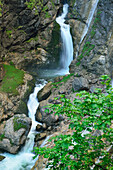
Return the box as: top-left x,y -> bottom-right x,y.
56,4 -> 73,72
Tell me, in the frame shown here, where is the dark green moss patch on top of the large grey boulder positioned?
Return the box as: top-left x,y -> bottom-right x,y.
13,116 -> 27,131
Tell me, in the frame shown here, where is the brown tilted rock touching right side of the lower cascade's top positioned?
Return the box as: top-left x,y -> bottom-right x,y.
37,82 -> 52,102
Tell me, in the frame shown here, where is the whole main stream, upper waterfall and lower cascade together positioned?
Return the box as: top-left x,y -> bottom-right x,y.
0,1 -> 73,170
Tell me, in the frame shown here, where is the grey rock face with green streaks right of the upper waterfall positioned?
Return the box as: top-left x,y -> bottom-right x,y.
70,0 -> 113,79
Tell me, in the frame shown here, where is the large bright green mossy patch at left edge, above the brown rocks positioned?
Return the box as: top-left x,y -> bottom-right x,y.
0,65 -> 24,95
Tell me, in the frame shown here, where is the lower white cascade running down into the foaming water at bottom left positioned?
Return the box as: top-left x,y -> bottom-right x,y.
0,81 -> 46,170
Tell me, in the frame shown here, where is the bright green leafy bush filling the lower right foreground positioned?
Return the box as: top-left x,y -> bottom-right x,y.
34,75 -> 113,170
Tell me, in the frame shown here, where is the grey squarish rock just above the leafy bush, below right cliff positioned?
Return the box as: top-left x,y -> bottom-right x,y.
72,77 -> 89,91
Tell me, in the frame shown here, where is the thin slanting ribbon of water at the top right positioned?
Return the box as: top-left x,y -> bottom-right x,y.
80,0 -> 99,44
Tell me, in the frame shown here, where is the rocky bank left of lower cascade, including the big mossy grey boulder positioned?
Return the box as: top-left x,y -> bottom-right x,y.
0,74 -> 33,154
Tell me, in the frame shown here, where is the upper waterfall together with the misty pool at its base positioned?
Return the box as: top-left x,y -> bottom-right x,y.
36,4 -> 73,78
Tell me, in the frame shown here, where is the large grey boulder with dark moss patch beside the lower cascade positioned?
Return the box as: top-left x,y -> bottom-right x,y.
0,114 -> 31,154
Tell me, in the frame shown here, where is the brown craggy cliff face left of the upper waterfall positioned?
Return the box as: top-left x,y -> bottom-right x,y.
0,0 -> 60,70
